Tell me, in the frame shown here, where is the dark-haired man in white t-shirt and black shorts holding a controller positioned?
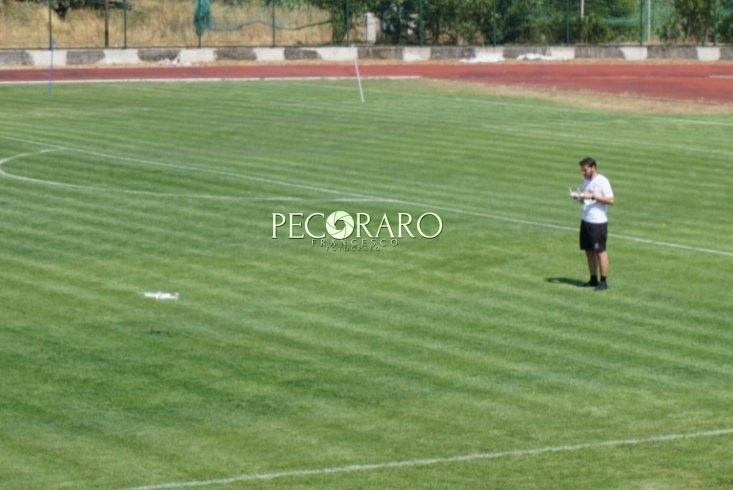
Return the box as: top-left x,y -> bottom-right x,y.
571,157 -> 614,291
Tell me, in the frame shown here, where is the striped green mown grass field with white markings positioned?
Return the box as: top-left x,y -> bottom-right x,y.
0,80 -> 733,490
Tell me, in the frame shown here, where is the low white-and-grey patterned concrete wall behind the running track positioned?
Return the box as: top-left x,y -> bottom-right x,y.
0,46 -> 733,67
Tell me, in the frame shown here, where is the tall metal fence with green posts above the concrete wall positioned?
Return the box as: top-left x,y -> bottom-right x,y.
0,0 -> 733,49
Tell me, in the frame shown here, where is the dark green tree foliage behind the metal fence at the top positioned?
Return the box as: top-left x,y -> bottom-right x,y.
15,0 -> 733,44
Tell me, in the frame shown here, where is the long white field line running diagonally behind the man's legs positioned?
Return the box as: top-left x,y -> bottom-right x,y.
0,136 -> 733,257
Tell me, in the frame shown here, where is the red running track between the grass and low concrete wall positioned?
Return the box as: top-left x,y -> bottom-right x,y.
0,63 -> 733,104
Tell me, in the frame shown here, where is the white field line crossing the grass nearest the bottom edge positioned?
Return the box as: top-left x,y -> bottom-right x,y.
126,429 -> 733,490
